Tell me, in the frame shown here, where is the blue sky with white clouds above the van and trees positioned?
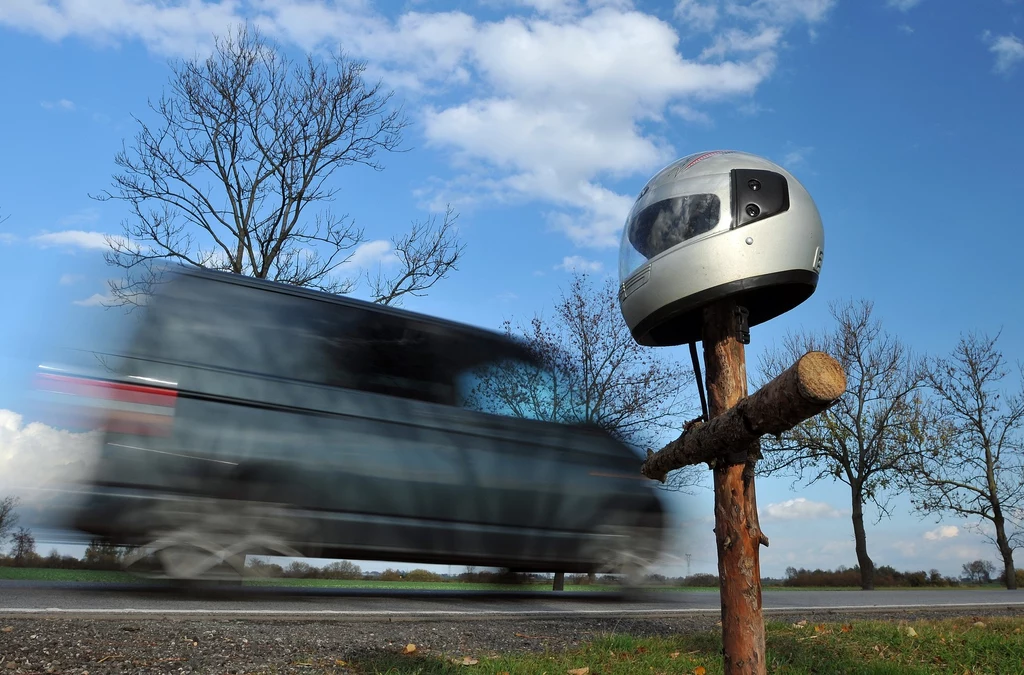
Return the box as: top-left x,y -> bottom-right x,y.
0,0 -> 1024,576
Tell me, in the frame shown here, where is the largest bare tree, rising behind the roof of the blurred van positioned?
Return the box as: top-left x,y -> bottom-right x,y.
96,26 -> 463,306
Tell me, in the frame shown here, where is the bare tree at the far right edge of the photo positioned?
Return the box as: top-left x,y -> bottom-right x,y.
909,334 -> 1024,589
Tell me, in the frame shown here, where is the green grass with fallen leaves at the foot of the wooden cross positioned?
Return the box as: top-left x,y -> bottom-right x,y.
350,619 -> 1024,675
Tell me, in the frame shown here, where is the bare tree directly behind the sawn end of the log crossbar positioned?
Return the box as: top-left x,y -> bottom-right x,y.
758,300 -> 924,590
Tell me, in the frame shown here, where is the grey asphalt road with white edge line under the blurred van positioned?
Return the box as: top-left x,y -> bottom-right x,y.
0,581 -> 1024,620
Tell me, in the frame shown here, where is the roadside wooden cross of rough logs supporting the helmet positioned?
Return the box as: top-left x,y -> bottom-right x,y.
641,298 -> 846,675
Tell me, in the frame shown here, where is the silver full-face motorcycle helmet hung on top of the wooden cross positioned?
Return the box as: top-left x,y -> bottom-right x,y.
618,151 -> 824,346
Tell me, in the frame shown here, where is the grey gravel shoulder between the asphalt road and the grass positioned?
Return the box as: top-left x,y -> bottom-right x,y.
0,608 -> 1024,675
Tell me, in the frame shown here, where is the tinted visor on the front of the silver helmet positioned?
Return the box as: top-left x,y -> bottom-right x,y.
618,173 -> 732,282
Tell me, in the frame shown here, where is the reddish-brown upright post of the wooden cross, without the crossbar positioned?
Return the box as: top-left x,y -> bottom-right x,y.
704,300 -> 770,675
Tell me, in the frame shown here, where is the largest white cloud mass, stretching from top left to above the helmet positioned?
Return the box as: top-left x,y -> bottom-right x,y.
0,0 -> 836,247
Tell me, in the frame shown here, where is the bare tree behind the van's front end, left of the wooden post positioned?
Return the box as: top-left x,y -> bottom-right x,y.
467,273 -> 699,490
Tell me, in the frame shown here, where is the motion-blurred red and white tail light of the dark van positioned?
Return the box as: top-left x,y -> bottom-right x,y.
36,373 -> 178,436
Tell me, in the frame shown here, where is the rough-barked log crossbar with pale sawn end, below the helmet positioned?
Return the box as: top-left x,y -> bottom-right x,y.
640,351 -> 846,482
